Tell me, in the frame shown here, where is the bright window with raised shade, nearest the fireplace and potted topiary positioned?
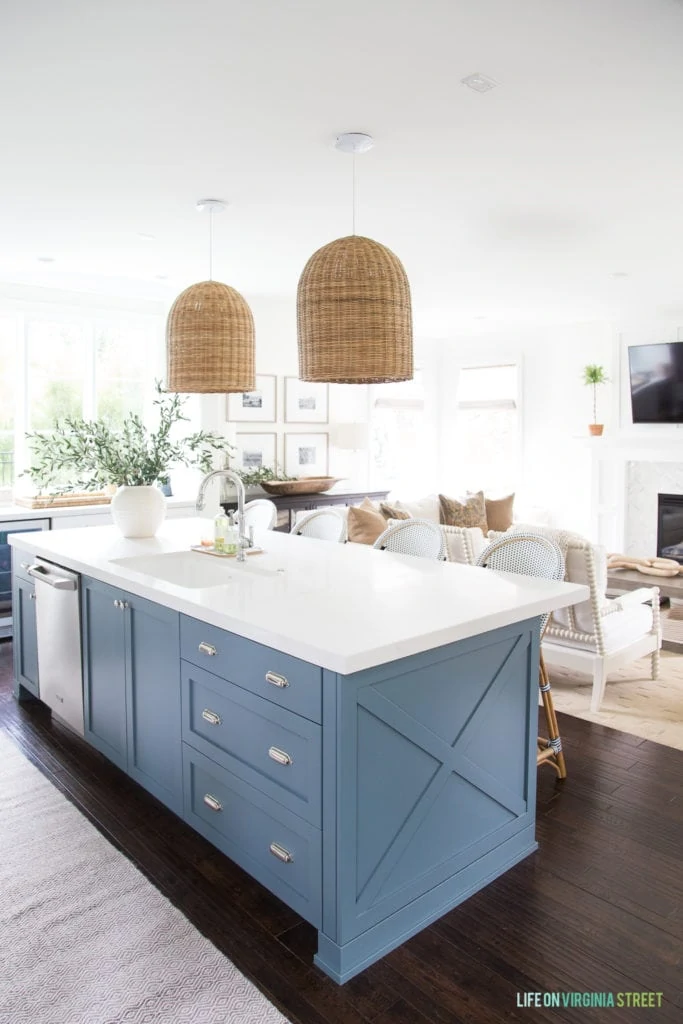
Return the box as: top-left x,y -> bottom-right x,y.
456,364 -> 520,495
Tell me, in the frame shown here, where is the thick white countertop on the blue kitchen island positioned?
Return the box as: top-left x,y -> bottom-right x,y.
9,518 -> 589,675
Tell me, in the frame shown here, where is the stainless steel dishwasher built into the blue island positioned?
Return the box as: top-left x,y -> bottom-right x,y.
28,558 -> 83,735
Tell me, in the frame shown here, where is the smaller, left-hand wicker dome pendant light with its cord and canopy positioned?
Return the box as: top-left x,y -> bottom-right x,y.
166,200 -> 256,394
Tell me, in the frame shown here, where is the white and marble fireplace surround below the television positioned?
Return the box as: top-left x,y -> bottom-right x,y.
591,432 -> 683,558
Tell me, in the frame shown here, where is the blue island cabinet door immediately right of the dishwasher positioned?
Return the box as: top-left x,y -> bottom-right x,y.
81,577 -> 127,771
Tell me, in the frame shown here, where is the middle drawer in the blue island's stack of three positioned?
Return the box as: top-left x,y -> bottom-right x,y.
181,662 -> 321,825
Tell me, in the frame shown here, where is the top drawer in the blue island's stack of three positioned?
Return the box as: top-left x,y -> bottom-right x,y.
180,615 -> 323,722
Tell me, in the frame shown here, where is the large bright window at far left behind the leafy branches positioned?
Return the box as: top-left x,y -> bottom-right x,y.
0,307 -> 163,501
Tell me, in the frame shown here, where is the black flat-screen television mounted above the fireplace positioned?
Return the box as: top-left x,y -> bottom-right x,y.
629,341 -> 683,423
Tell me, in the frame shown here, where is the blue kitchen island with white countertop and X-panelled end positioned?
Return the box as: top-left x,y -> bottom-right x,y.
12,520 -> 585,983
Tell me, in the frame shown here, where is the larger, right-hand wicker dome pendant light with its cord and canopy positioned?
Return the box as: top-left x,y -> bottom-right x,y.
297,132 -> 413,384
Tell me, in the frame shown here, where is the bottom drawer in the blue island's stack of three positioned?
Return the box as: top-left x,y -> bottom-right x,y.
183,743 -> 323,928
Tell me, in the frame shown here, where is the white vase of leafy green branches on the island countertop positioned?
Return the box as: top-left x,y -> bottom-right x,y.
27,382 -> 233,537
